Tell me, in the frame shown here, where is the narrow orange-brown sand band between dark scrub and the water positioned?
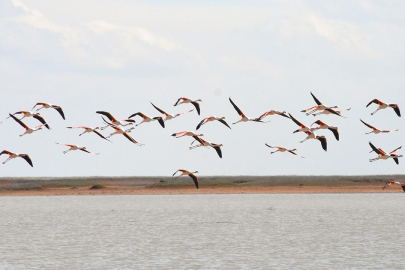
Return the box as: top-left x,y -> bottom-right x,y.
0,184 -> 403,196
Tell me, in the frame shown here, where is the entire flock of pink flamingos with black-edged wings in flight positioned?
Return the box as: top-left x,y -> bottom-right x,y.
0,92 -> 405,192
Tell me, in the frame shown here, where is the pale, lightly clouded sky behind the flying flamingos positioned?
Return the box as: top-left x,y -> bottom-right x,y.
0,0 -> 405,177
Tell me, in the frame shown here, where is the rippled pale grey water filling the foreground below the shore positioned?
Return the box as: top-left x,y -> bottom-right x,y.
0,193 -> 405,269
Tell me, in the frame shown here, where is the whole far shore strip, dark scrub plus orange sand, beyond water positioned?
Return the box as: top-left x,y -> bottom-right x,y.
0,175 -> 405,196
